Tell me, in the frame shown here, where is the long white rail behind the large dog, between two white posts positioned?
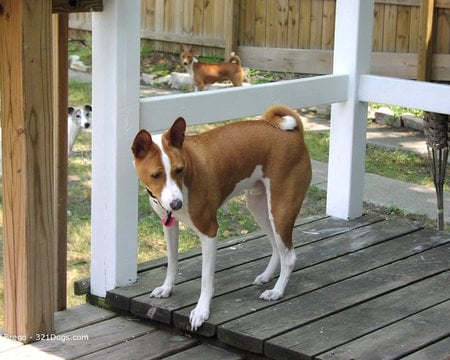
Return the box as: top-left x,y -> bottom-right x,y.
140,75 -> 348,131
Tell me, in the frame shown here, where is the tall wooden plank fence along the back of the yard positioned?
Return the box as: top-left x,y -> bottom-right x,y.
70,0 -> 450,81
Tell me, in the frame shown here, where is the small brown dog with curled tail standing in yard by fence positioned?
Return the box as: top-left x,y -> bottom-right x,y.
180,46 -> 245,91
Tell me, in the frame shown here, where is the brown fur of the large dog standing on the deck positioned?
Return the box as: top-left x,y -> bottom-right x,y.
133,106 -> 311,245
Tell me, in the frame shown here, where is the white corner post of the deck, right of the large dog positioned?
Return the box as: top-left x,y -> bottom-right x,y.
327,0 -> 374,219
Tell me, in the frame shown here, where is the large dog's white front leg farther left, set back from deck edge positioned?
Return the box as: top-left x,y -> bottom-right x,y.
150,220 -> 180,298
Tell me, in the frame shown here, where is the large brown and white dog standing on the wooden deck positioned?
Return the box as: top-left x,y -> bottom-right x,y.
132,106 -> 311,330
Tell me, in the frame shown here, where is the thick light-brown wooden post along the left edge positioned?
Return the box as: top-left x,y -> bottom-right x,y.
0,0 -> 55,342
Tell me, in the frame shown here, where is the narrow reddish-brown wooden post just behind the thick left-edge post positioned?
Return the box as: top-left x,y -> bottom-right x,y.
53,14 -> 69,311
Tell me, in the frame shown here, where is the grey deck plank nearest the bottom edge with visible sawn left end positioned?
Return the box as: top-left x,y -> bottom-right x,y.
264,271 -> 450,360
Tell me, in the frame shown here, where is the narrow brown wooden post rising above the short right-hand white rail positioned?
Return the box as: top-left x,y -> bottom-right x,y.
417,0 -> 434,81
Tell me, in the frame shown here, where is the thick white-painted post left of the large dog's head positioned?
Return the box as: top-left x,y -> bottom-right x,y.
91,0 -> 140,297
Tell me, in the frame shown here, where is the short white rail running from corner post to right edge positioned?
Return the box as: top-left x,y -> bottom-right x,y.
358,75 -> 450,114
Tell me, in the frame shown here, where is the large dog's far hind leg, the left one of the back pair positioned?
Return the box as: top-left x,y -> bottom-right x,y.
246,183 -> 280,285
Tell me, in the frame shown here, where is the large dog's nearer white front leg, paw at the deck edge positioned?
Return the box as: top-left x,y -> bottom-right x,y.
189,235 -> 217,331
